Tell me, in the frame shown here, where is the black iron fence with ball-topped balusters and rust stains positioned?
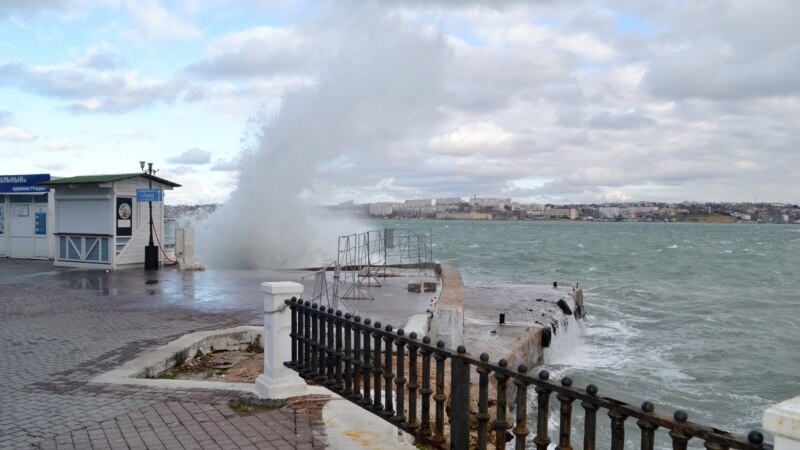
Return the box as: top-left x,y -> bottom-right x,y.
285,298 -> 773,450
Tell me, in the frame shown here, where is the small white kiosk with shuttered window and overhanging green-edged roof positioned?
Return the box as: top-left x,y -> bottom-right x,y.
41,173 -> 180,270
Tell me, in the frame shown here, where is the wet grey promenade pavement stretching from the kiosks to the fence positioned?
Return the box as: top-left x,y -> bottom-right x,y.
0,259 -> 435,449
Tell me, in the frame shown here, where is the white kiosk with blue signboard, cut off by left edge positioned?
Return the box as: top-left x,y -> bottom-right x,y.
0,173 -> 55,259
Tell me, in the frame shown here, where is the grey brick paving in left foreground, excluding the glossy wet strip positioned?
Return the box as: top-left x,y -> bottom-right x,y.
0,259 -> 325,449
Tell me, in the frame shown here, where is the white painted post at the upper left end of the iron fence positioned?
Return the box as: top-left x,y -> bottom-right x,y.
256,281 -> 307,398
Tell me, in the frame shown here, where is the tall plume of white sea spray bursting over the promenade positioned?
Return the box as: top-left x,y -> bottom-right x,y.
197,2 -> 446,268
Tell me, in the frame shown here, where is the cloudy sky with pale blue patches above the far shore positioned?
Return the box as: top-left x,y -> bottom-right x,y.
0,0 -> 800,204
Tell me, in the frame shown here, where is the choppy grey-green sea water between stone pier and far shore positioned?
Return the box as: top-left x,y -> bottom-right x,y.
376,221 -> 800,434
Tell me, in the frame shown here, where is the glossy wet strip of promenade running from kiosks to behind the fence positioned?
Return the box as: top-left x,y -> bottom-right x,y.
0,258 -> 438,327
